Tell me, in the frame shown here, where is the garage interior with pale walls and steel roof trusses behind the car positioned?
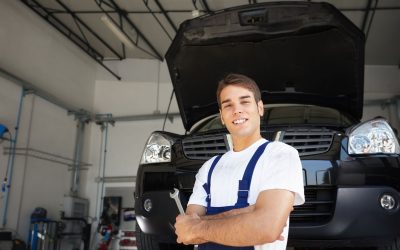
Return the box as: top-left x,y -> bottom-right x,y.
0,0 -> 400,250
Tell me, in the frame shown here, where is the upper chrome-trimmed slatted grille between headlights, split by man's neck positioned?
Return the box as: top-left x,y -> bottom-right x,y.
183,129 -> 334,160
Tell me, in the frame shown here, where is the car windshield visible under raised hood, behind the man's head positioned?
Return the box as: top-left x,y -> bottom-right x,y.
196,105 -> 354,132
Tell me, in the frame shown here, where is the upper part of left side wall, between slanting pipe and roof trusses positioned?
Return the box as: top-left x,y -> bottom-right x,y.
0,0 -> 96,111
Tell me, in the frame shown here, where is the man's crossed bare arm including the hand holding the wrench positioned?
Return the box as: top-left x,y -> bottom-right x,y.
175,189 -> 294,246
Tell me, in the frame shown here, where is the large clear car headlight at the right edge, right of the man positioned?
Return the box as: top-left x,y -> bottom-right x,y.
348,118 -> 400,154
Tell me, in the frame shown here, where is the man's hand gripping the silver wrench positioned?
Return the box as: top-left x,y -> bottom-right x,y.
175,214 -> 205,245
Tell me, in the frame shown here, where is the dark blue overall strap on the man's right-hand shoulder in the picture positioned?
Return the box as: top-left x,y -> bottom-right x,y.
235,141 -> 269,207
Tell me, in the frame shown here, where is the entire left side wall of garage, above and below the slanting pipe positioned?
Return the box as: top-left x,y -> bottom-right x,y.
0,0 -> 97,244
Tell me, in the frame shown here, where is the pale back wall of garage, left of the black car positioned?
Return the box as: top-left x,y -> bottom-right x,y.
83,59 -> 185,228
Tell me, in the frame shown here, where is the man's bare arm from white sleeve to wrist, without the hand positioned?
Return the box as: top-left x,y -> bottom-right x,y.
194,190 -> 294,246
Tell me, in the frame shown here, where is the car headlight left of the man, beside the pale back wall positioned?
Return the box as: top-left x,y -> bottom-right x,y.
140,133 -> 172,164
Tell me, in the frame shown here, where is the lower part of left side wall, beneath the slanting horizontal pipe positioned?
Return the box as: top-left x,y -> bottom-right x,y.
0,77 -> 76,240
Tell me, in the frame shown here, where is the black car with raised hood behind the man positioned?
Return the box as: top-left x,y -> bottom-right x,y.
135,2 -> 400,250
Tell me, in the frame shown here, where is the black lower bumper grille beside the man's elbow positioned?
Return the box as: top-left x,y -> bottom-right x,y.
290,186 -> 337,224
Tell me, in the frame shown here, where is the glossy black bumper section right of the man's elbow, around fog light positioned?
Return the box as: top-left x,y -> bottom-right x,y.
289,186 -> 400,246
